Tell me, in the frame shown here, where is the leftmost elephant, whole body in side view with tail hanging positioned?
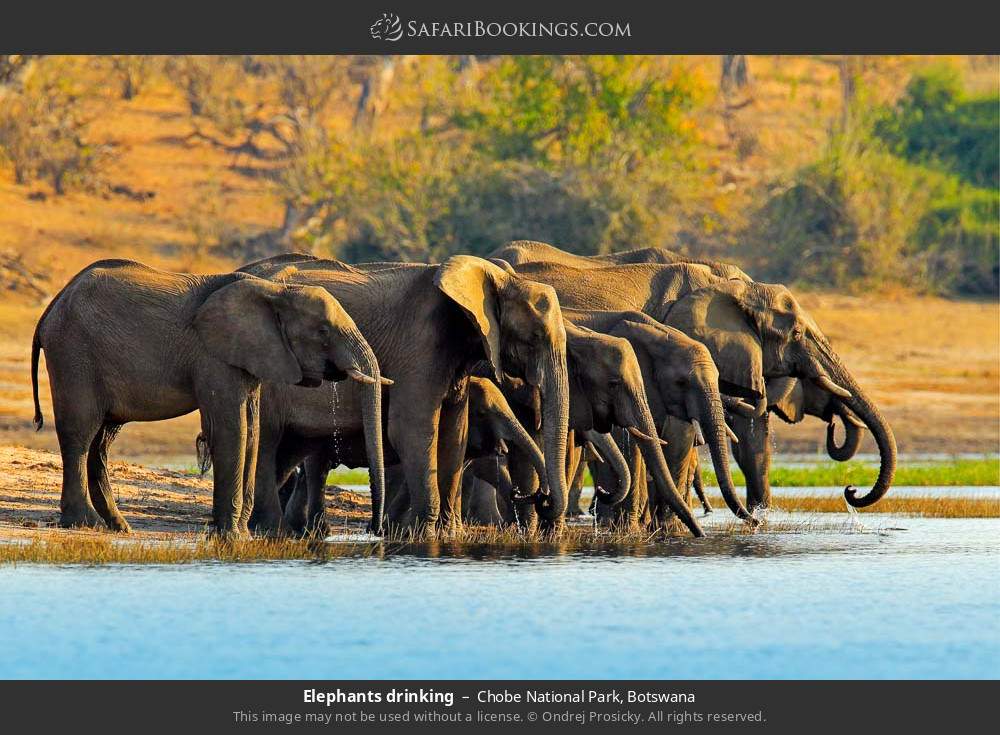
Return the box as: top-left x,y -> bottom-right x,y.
31,260 -> 388,537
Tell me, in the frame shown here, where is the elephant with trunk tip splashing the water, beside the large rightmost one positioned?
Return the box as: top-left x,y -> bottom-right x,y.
563,308 -> 753,520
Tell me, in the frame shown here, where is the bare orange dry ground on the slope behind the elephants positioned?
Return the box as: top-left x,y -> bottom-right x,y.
0,57 -> 1000,466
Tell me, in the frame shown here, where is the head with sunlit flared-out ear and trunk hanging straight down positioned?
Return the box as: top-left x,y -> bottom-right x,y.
435,255 -> 569,523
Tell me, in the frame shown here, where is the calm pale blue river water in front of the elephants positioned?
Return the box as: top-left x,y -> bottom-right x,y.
0,513 -> 1000,679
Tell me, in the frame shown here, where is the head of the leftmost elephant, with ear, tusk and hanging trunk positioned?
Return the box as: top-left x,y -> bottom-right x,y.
193,276 -> 392,533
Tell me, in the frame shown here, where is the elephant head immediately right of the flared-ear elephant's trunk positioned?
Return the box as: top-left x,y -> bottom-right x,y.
566,322 -> 704,536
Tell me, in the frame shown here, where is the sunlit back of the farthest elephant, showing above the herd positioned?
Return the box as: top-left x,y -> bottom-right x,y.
487,240 -> 752,281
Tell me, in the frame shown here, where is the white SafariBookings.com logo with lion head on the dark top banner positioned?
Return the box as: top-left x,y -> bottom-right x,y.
369,13 -> 632,41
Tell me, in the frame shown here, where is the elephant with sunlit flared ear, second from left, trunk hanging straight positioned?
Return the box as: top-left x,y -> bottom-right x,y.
241,254 -> 569,534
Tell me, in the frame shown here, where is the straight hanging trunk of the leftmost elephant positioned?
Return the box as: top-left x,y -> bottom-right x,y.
337,329 -> 391,536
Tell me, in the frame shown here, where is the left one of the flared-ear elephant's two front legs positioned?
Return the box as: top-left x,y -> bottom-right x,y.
389,396 -> 441,535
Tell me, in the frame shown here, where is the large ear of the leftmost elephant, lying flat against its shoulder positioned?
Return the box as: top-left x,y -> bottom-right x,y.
194,278 -> 302,385
